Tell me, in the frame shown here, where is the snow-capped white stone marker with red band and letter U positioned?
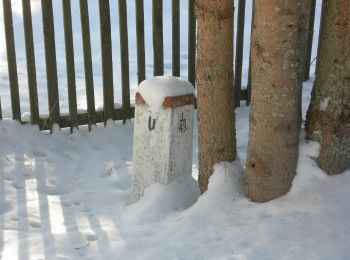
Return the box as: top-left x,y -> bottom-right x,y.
132,76 -> 195,201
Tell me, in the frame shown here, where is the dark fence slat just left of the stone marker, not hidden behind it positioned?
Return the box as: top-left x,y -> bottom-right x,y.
119,0 -> 131,122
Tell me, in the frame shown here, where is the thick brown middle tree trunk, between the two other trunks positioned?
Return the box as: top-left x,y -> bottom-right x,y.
245,0 -> 307,202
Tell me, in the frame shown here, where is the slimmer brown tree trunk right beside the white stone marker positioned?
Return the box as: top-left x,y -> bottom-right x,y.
196,0 -> 236,193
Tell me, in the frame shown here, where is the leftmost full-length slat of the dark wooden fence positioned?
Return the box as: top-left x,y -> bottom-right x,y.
2,0 -> 21,121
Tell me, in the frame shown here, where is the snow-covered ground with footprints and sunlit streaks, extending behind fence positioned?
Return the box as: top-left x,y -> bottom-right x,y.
0,0 -> 350,260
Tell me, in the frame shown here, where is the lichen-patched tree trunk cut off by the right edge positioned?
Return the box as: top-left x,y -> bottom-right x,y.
306,0 -> 350,174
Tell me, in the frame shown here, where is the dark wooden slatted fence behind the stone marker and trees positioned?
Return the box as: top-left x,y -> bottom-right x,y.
0,0 -> 315,130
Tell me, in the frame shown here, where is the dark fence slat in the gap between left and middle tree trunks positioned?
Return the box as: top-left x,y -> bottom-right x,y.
234,0 -> 245,107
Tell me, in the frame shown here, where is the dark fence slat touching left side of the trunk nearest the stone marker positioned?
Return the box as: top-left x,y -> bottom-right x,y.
188,0 -> 196,86
